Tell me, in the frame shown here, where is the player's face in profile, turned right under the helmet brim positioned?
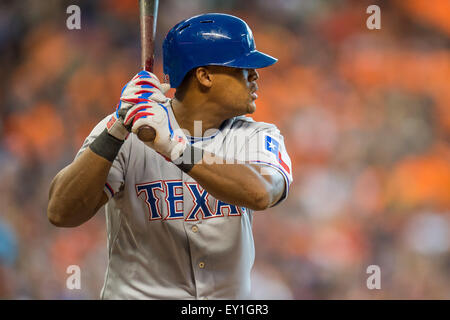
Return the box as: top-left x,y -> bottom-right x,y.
208,67 -> 259,116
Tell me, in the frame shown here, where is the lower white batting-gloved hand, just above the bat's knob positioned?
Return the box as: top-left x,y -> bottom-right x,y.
124,101 -> 188,161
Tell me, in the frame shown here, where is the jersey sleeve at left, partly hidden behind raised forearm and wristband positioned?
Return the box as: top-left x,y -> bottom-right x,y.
75,115 -> 127,199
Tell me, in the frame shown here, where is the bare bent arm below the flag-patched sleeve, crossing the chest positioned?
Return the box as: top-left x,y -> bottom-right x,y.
185,152 -> 284,210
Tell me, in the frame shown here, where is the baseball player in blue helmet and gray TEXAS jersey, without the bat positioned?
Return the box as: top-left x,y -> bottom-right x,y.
48,14 -> 292,299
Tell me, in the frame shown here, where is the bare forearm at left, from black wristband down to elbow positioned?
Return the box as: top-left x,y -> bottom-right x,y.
47,148 -> 112,227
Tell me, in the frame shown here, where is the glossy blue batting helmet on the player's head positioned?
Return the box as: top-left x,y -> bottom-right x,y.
163,13 -> 277,88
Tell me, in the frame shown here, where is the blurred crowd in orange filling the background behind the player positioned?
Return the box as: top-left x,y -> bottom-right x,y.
0,0 -> 450,299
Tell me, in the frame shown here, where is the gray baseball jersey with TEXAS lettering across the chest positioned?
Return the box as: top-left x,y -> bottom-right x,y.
77,100 -> 292,299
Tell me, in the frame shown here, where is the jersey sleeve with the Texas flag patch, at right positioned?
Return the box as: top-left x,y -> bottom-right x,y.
240,125 -> 293,205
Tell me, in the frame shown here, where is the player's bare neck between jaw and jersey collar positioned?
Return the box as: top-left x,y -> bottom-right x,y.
172,98 -> 228,136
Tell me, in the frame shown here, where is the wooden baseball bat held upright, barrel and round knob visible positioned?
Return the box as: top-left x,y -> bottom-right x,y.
137,0 -> 159,141
